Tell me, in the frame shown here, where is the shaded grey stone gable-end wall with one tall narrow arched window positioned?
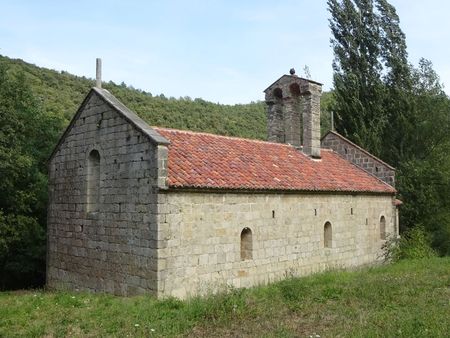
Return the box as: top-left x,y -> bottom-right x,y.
47,91 -> 160,295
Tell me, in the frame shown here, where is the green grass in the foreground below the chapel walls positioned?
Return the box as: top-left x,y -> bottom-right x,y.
0,258 -> 450,337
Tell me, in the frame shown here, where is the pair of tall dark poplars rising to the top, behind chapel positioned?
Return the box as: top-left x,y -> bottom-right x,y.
328,0 -> 409,156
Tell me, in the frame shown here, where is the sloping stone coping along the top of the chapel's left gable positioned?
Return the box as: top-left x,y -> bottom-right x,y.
48,87 -> 170,163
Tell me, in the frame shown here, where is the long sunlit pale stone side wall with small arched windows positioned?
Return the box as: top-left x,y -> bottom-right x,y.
158,191 -> 395,298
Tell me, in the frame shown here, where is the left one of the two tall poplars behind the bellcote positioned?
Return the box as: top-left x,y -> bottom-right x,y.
328,0 -> 385,154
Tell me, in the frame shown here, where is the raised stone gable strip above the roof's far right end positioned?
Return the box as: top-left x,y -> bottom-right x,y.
322,132 -> 395,186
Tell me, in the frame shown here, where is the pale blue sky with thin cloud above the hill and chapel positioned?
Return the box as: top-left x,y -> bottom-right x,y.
0,0 -> 450,104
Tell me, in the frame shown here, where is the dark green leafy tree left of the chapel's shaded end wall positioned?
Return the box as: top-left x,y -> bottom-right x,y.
0,64 -> 62,288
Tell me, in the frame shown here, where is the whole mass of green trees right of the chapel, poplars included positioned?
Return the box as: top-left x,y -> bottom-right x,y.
328,0 -> 450,254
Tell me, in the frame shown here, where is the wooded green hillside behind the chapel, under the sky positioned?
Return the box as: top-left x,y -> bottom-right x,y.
0,55 -> 331,139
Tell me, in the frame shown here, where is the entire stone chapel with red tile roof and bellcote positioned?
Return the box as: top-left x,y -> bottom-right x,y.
47,74 -> 400,298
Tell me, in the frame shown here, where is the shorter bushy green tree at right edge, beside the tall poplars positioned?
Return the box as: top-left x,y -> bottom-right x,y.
398,59 -> 450,255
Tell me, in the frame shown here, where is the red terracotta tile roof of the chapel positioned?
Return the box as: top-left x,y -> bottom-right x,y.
154,128 -> 395,193
